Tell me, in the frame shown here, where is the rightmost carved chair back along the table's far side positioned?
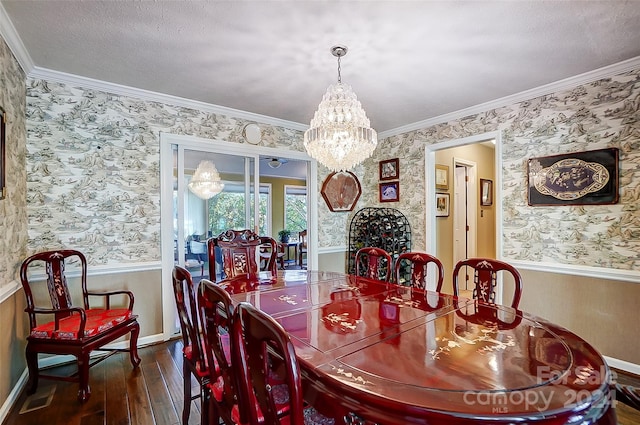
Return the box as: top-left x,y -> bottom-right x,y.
453,258 -> 522,308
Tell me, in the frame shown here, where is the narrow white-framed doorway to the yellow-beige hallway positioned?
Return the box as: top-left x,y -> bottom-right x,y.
425,132 -> 501,292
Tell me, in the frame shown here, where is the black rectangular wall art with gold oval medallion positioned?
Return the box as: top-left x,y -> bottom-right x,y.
528,148 -> 618,206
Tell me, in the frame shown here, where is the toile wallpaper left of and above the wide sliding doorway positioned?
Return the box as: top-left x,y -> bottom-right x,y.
27,79 -> 304,265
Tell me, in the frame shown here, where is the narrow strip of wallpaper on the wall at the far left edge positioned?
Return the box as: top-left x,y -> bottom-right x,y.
0,37 -> 27,287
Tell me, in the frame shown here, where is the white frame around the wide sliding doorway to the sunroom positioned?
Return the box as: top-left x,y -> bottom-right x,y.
160,133 -> 318,341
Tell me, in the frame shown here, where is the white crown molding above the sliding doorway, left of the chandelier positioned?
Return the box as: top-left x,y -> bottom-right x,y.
27,66 -> 309,131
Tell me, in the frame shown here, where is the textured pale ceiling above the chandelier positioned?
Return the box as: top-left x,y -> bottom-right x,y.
0,0 -> 640,132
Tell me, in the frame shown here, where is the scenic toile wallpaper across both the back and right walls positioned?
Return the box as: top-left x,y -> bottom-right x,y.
27,66 -> 640,270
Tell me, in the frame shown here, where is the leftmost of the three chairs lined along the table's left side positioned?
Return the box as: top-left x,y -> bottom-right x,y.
172,266 -> 212,425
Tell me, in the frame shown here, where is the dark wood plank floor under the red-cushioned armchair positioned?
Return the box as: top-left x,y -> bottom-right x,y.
3,339 -> 640,425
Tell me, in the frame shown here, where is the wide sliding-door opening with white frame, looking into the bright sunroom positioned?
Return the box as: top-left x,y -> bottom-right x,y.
160,134 -> 318,339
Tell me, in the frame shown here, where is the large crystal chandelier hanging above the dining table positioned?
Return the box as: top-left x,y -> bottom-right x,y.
304,46 -> 378,171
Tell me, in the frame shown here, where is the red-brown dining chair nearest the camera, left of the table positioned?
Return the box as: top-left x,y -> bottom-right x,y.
232,302 -> 335,425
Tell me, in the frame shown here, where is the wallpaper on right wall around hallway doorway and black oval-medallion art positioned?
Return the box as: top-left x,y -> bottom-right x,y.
359,70 -> 640,270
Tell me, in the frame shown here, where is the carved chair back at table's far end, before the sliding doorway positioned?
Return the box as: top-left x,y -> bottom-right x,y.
207,229 -> 277,282
